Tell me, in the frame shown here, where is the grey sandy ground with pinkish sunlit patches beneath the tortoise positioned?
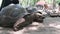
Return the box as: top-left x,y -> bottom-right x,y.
0,17 -> 60,34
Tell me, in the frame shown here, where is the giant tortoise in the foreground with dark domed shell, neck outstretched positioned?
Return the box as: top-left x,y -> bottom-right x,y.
0,4 -> 43,31
